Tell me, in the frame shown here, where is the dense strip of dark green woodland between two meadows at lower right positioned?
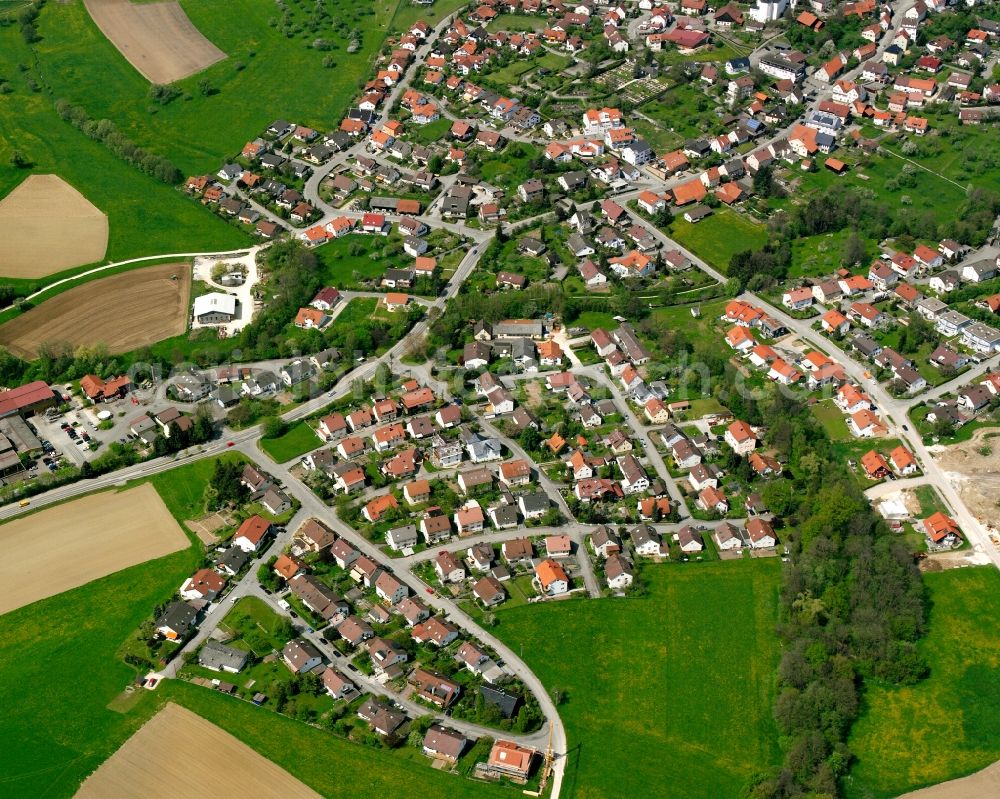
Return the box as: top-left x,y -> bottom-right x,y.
731,392 -> 927,799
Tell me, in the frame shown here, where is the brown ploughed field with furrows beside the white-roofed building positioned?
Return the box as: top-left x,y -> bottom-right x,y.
0,263 -> 191,359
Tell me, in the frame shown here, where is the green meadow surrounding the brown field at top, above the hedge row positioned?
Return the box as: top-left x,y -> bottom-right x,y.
28,0 -> 398,175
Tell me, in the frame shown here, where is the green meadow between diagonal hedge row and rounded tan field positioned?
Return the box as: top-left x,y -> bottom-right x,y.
0,19 -> 250,288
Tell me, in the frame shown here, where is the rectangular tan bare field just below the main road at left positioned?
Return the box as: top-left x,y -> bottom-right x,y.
0,483 -> 188,613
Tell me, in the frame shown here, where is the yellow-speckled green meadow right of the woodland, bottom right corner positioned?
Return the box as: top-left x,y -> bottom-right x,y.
846,567 -> 1000,799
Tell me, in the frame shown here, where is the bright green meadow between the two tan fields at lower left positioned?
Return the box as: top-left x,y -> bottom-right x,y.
0,524 -> 200,799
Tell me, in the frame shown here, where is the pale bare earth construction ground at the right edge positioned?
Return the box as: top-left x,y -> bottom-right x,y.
933,427 -> 1000,525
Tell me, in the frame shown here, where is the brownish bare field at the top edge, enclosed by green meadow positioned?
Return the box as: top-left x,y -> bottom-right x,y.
83,0 -> 226,83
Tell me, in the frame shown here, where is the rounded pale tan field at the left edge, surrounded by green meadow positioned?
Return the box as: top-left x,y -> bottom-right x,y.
0,175 -> 108,279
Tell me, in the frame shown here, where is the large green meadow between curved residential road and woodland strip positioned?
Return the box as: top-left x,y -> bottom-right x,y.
496,560 -> 780,799
